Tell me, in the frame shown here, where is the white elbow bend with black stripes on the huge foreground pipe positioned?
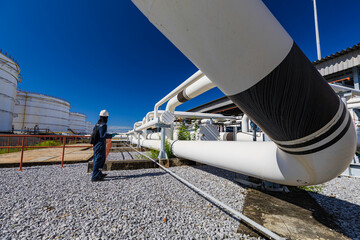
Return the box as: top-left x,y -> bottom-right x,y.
276,104 -> 357,186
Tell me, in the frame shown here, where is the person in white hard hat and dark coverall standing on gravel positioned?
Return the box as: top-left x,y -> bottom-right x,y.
90,110 -> 115,182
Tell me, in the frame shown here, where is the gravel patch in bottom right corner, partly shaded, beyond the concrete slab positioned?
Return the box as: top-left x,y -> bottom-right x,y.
310,176 -> 360,240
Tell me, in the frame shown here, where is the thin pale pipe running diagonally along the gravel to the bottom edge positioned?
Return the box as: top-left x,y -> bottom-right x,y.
128,145 -> 285,240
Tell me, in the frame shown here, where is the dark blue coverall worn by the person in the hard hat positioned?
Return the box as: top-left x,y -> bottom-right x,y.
92,123 -> 112,180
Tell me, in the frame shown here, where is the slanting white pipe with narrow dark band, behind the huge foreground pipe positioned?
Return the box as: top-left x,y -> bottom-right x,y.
166,76 -> 216,112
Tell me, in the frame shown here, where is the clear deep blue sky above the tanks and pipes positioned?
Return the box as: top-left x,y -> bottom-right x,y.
0,0 -> 360,131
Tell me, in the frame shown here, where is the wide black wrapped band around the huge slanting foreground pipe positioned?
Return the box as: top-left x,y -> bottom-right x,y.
228,42 -> 350,152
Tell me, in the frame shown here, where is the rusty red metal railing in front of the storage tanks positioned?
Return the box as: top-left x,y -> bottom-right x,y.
0,134 -> 111,171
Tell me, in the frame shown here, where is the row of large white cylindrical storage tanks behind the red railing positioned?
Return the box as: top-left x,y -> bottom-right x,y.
0,49 -> 93,135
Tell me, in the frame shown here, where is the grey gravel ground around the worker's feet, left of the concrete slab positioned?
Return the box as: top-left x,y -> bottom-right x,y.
0,164 -> 260,239
